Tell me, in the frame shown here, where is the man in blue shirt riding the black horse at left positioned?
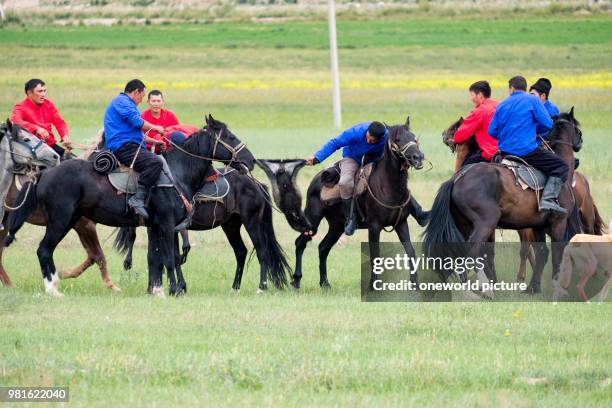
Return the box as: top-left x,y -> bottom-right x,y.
104,79 -> 164,219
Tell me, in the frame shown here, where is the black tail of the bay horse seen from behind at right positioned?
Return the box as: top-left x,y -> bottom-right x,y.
423,179 -> 465,252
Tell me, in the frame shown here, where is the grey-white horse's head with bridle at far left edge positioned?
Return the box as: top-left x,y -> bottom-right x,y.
0,120 -> 60,167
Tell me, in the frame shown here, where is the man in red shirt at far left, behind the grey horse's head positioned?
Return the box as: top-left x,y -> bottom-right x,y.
11,79 -> 72,157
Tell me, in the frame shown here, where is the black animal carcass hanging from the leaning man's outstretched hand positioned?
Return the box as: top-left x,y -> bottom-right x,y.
256,159 -> 312,233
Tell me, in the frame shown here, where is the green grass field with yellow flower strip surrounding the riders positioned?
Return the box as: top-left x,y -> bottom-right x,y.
0,16 -> 612,407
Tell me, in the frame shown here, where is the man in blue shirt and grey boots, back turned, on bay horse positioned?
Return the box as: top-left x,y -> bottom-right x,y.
489,76 -> 569,214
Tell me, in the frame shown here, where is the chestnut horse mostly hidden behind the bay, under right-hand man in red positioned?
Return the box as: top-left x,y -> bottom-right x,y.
442,117 -> 605,282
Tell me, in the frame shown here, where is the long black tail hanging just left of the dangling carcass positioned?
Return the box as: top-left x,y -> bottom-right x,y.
257,186 -> 291,288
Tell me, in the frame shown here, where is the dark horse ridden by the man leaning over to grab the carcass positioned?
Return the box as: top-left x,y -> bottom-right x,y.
291,117 -> 425,289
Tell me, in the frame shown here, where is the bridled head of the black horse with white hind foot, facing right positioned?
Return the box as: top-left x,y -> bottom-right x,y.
204,115 -> 255,174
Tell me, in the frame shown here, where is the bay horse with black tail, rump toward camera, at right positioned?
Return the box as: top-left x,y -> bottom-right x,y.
423,108 -> 582,293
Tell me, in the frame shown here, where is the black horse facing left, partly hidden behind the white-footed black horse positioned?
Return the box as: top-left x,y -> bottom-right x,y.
115,171 -> 291,291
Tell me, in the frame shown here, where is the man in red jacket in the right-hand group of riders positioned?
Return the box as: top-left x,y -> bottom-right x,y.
453,81 -> 499,166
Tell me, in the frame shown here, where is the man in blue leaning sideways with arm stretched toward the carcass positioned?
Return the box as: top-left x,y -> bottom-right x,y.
306,122 -> 387,235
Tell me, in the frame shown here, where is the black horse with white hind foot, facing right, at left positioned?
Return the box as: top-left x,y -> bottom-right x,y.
9,115 -> 255,296
